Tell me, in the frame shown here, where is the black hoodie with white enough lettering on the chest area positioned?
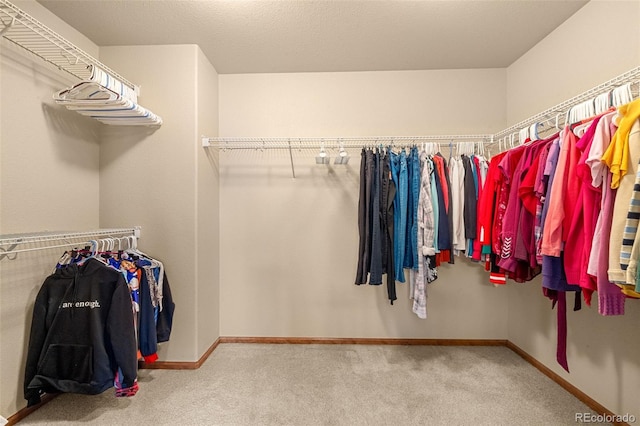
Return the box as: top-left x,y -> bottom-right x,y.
24,259 -> 137,406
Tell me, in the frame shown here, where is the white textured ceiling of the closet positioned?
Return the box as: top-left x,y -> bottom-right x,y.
33,0 -> 587,74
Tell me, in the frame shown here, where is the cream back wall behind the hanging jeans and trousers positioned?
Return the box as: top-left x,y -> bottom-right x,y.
220,69 -> 507,339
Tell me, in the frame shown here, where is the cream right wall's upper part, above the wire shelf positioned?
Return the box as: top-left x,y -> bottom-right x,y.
507,0 -> 640,124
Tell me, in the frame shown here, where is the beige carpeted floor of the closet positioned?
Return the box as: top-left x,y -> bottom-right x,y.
20,344 -> 594,426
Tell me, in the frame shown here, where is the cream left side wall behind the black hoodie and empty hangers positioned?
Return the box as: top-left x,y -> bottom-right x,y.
0,2 -> 100,417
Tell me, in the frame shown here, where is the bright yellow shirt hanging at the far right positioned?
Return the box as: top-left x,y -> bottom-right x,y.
602,99 -> 640,189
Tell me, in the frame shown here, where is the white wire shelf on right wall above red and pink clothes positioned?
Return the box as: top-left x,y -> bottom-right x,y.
493,66 -> 640,140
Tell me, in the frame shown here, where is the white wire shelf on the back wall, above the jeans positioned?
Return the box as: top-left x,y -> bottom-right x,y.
202,135 -> 491,150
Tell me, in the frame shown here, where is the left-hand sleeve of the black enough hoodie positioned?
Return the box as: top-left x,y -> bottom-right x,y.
24,280 -> 49,407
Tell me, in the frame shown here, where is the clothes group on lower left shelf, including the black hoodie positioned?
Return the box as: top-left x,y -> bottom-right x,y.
25,240 -> 175,404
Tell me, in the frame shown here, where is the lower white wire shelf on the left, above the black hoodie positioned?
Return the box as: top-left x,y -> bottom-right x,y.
0,226 -> 142,259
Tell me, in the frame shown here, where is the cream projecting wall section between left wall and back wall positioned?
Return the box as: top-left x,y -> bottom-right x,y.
100,45 -> 218,361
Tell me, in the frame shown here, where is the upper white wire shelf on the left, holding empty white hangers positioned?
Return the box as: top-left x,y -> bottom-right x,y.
0,0 -> 140,93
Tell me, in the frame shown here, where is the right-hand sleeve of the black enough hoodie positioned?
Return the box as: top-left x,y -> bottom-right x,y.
106,274 -> 138,388
